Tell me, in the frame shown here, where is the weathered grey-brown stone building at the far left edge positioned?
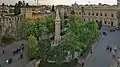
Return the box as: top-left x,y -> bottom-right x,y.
0,14 -> 22,38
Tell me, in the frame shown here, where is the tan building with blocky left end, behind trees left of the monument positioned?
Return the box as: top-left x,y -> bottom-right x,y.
21,6 -> 52,20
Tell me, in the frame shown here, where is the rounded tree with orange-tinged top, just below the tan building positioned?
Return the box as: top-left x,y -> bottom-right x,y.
21,19 -> 48,39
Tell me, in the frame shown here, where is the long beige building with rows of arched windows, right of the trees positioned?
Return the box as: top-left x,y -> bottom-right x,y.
75,7 -> 118,27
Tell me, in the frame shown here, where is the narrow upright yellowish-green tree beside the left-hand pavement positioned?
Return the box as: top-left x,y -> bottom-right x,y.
28,35 -> 38,60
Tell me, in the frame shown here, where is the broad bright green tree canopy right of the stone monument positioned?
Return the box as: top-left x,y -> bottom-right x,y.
64,16 -> 99,56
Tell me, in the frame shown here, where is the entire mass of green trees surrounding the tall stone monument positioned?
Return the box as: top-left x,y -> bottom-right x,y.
21,16 -> 99,64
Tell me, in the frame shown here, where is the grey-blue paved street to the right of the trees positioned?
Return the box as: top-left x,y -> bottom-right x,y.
84,27 -> 120,67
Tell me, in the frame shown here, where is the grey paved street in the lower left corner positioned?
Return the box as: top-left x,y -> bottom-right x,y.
0,41 -> 28,67
